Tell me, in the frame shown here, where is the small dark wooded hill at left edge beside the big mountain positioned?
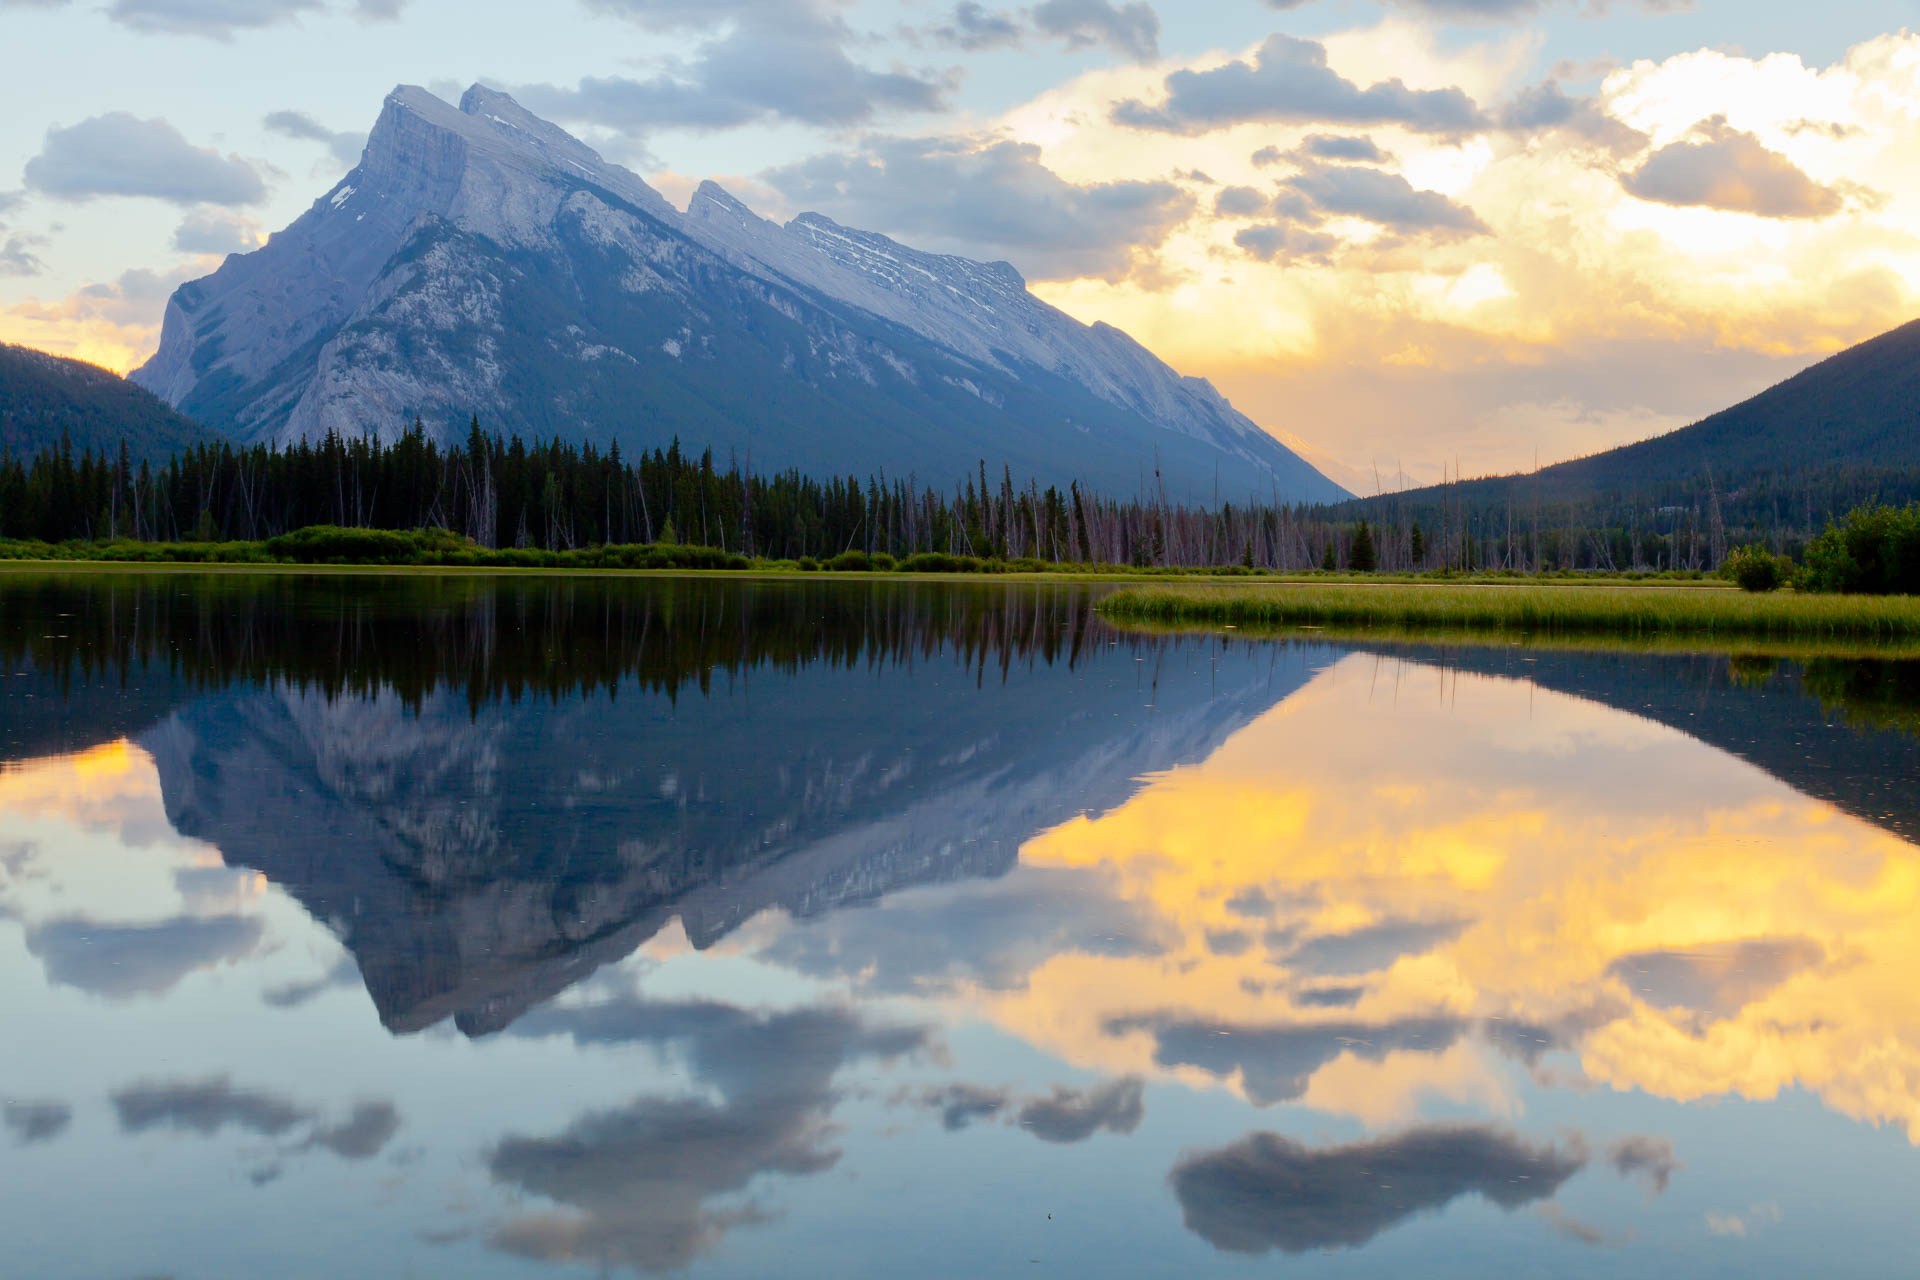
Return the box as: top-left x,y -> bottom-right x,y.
0,344 -> 215,462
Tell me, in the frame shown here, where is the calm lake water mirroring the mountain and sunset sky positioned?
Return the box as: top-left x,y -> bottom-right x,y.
0,578 -> 1920,1280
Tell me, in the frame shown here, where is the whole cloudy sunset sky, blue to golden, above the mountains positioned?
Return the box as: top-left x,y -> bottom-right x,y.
0,0 -> 1920,493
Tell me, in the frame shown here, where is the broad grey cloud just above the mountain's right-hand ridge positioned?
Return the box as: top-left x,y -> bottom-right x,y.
766,138 -> 1194,280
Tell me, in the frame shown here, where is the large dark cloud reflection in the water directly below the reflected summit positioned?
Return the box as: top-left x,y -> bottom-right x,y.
490,1000 -> 925,1270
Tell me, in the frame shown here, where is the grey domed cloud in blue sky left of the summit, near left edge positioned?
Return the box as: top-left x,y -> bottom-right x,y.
25,111 -> 267,205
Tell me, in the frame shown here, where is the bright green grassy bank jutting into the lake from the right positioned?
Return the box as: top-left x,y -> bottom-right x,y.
1100,585 -> 1920,645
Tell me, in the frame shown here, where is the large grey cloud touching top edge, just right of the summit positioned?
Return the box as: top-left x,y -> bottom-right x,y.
515,0 -> 948,132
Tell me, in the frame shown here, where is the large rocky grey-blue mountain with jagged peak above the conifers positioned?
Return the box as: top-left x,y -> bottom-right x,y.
134,86 -> 1344,501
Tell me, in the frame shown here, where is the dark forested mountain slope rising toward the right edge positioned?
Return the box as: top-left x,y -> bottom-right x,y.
1386,320 -> 1920,526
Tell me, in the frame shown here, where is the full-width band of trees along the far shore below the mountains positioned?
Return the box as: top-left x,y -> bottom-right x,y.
0,422 -> 1920,574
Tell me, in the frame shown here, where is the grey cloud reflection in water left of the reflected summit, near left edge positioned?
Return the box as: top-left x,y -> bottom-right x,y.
27,915 -> 261,1000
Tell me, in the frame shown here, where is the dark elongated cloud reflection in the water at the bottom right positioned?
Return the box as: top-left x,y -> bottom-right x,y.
1171,1126 -> 1586,1253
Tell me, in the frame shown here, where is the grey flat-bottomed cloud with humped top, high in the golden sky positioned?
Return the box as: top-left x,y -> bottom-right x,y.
1112,35 -> 1486,134
